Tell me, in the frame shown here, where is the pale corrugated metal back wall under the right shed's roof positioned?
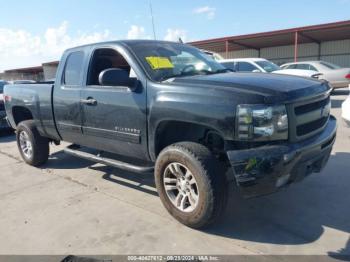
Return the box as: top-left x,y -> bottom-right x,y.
220,39 -> 350,67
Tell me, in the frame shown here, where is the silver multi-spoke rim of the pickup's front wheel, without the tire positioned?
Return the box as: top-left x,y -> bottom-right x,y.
163,162 -> 199,212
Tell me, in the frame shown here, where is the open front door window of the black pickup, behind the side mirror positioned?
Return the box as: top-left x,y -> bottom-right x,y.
87,48 -> 137,85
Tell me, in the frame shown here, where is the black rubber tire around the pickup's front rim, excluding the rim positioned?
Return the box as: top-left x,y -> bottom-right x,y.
154,142 -> 227,229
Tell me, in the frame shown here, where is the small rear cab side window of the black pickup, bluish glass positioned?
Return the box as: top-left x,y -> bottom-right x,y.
63,51 -> 84,86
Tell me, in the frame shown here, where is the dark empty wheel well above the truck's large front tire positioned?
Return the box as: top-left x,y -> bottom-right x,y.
155,121 -> 224,156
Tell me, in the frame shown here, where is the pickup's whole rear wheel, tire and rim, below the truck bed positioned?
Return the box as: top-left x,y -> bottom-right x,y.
16,120 -> 49,166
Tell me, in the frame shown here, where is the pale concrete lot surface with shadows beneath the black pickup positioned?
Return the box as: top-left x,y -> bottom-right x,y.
0,89 -> 350,256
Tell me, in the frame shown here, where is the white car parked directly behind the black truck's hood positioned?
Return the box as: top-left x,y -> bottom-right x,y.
218,58 -> 320,78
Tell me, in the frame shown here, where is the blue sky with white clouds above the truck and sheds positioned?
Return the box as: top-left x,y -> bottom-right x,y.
0,0 -> 350,72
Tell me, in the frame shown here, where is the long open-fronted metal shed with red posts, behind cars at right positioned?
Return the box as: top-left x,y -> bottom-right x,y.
189,20 -> 350,67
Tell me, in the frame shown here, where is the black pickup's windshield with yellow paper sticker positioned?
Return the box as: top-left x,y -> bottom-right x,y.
128,42 -> 228,82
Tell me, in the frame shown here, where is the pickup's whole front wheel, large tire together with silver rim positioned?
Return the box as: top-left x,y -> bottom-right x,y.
155,142 -> 227,228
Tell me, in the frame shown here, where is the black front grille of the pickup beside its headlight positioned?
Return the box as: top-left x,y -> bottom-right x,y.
289,96 -> 331,140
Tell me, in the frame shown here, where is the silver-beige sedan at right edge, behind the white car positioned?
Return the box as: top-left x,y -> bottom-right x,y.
281,61 -> 350,88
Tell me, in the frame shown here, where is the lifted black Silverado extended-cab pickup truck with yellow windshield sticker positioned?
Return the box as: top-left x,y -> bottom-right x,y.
4,40 -> 336,228
